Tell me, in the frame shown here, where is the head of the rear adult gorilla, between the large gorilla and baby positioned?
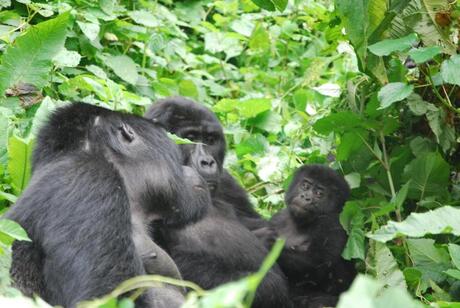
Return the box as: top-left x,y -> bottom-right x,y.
145,97 -> 225,190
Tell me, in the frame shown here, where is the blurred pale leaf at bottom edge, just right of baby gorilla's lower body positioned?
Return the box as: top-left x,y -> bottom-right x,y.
337,274 -> 423,308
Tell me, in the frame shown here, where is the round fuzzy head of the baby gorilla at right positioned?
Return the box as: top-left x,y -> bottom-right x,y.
285,165 -> 350,220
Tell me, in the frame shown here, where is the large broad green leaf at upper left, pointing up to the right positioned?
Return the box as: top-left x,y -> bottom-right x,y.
0,13 -> 70,96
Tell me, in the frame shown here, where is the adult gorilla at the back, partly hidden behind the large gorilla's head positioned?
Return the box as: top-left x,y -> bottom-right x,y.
145,97 -> 267,230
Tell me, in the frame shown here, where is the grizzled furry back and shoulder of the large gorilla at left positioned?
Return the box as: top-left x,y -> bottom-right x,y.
6,154 -> 144,307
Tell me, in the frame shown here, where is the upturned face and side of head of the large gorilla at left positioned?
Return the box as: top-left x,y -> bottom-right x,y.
91,113 -> 204,224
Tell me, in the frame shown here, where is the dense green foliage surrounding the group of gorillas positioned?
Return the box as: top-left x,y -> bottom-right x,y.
0,0 -> 460,307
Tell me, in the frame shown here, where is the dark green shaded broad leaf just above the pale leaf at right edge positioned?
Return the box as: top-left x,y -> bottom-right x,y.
403,152 -> 450,200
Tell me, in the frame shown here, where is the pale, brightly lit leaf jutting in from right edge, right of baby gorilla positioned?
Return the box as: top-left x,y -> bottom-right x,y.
367,206 -> 460,242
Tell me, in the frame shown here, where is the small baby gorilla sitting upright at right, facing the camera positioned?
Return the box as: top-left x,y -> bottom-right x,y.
270,165 -> 356,307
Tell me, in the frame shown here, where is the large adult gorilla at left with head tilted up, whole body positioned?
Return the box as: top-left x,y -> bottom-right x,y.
6,104 -> 204,307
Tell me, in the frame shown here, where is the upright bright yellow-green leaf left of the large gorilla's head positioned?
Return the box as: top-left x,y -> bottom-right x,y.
8,136 -> 33,192
